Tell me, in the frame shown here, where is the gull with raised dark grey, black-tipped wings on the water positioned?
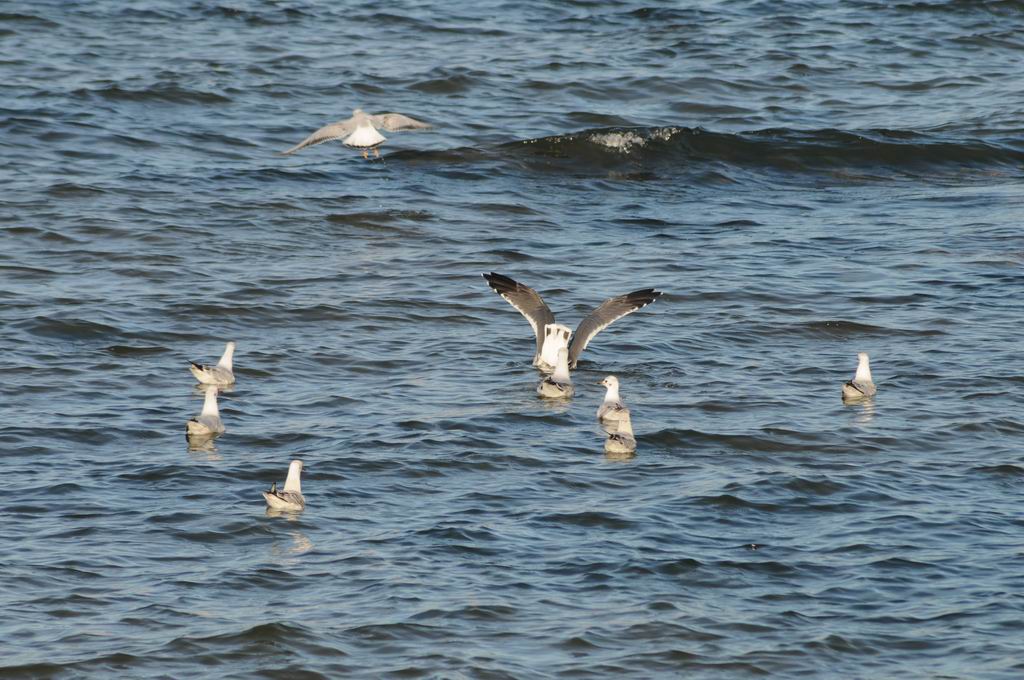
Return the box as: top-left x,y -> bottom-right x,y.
483,271 -> 662,373
